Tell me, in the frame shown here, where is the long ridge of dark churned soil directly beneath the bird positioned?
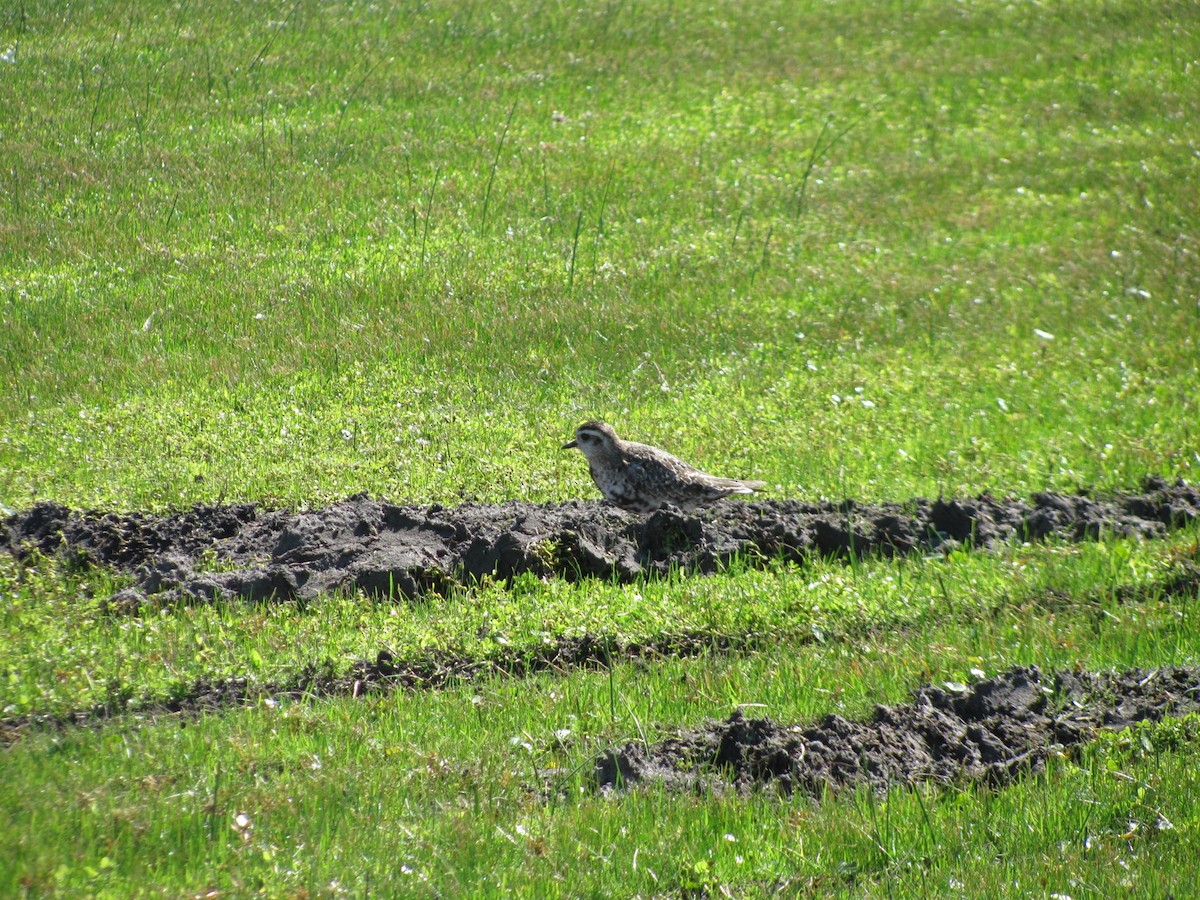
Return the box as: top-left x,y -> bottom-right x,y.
4,479 -> 1200,606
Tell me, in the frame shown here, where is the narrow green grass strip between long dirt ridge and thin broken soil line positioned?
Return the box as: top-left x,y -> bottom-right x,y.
0,533 -> 1196,715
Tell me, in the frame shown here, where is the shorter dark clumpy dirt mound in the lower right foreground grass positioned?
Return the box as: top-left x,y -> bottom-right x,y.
594,667 -> 1200,797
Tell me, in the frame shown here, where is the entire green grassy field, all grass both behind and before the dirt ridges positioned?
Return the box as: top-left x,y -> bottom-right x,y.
0,0 -> 1200,898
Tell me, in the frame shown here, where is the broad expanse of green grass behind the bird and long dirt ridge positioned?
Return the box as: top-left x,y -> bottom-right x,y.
0,2 -> 1200,508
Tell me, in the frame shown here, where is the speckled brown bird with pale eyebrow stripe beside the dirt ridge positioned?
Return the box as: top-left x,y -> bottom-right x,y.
563,421 -> 767,514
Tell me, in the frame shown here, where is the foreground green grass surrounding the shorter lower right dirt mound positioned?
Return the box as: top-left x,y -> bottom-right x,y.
0,532 -> 1200,896
